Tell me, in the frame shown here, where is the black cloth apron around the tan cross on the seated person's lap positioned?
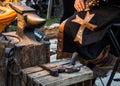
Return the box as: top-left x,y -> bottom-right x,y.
63,6 -> 120,59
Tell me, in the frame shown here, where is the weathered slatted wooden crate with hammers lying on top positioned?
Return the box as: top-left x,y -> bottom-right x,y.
22,59 -> 93,86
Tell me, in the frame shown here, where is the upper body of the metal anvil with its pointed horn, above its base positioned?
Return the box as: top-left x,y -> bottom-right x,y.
10,2 -> 46,37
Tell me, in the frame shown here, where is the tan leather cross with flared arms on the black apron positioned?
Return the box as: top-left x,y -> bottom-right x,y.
72,12 -> 97,44
